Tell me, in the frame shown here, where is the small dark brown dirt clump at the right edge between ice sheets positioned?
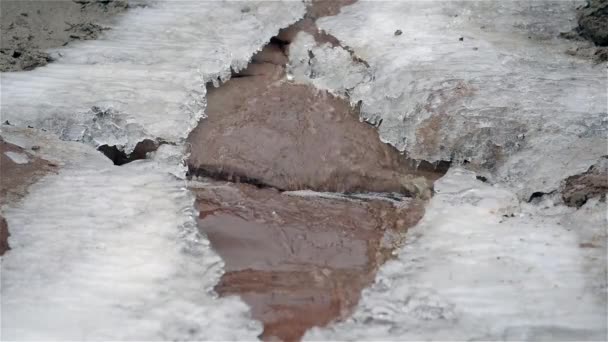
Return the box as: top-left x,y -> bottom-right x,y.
561,157 -> 608,208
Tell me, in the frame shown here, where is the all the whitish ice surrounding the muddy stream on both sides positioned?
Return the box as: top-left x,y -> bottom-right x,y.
0,1 -> 607,340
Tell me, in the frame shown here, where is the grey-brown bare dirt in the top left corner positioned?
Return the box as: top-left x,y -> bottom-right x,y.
0,0 -> 129,72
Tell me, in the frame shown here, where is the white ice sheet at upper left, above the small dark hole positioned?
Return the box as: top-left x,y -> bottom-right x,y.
0,1 -> 304,153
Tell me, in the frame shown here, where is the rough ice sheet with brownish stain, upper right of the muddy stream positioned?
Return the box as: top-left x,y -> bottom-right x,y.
308,1 -> 608,199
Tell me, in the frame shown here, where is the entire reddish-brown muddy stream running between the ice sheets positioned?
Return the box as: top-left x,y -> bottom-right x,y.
188,1 -> 445,341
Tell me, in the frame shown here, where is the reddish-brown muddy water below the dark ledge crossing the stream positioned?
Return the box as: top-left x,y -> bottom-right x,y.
194,182 -> 424,341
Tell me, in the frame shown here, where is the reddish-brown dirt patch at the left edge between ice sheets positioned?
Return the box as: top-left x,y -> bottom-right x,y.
0,137 -> 56,255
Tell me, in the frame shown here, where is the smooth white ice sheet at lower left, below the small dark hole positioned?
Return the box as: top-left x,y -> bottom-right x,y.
1,128 -> 261,340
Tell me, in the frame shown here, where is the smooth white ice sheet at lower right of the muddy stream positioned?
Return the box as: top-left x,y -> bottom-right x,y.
306,169 -> 608,340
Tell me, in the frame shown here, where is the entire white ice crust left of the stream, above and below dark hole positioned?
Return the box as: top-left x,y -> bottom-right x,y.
0,1 -> 304,341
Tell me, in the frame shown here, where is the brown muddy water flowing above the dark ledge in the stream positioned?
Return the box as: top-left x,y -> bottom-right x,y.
189,79 -> 439,193
